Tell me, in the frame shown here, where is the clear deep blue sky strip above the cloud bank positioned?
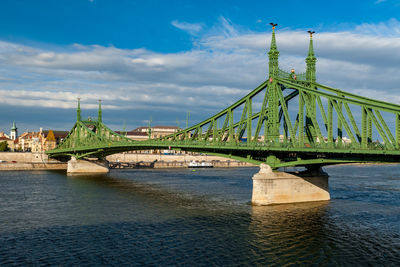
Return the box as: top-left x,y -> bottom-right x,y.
0,0 -> 400,52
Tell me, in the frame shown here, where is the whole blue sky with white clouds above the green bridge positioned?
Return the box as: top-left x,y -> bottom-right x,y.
0,0 -> 400,132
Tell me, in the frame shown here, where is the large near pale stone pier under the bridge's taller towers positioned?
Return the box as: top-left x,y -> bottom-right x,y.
251,164 -> 330,205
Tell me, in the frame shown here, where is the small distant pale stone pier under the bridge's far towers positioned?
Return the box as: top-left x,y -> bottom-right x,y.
67,157 -> 109,174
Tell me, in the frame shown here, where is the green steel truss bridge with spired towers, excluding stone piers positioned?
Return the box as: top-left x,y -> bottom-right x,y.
46,26 -> 400,169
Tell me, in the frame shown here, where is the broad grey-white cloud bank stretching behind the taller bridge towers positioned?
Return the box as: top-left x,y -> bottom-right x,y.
0,17 -> 400,130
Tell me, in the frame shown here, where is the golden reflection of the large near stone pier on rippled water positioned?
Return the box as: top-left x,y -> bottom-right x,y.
249,204 -> 328,266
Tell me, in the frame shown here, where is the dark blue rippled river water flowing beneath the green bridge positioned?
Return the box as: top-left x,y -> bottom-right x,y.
0,165 -> 400,266
